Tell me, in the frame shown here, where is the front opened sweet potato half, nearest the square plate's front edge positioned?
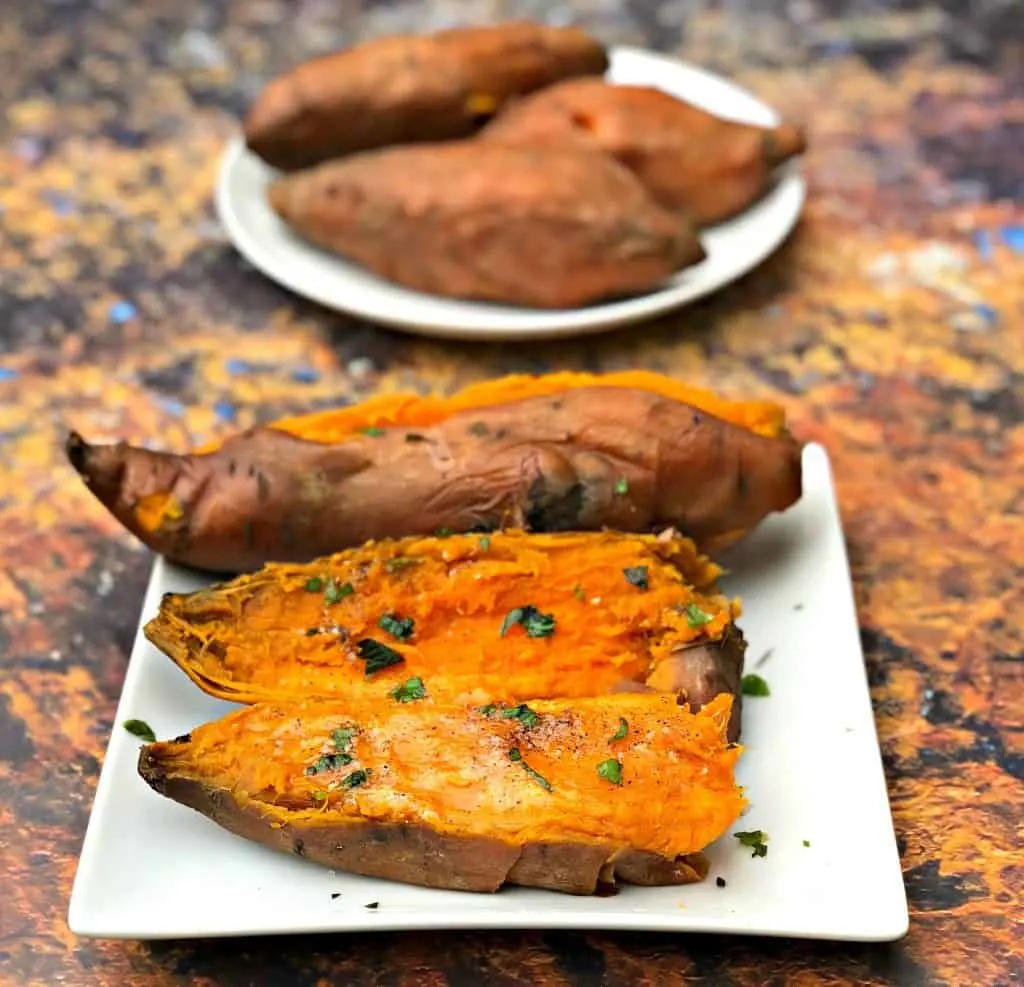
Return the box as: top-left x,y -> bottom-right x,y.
138,695 -> 744,895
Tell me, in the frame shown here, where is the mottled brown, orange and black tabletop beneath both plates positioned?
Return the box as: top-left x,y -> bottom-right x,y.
0,0 -> 1024,987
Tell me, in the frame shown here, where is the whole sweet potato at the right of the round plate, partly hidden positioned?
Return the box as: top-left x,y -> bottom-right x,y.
480,79 -> 806,226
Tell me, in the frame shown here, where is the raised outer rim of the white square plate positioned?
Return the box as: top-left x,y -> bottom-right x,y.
68,443 -> 909,942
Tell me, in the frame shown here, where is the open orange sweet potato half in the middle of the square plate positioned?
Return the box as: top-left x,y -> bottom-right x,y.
145,532 -> 744,739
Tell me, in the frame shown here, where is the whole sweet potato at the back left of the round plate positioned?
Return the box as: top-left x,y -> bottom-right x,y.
245,22 -> 608,170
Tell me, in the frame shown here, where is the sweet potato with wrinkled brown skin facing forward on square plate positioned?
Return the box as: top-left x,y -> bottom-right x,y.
68,375 -> 801,572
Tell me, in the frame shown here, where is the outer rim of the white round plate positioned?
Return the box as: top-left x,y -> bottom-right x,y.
214,45 -> 807,343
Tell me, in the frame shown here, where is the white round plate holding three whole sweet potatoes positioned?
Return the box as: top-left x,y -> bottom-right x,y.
216,48 -> 805,341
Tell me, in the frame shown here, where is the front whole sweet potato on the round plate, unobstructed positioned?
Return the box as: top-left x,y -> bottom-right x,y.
268,140 -> 705,308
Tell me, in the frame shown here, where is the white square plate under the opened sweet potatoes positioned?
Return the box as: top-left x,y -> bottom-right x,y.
69,446 -> 907,940
